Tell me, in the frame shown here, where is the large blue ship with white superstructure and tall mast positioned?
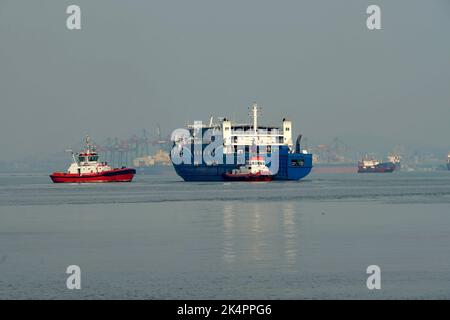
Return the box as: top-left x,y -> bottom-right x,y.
171,104 -> 312,181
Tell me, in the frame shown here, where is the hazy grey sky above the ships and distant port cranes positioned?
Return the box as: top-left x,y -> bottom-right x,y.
0,0 -> 450,160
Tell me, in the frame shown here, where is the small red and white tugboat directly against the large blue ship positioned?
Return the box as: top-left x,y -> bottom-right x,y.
223,157 -> 274,181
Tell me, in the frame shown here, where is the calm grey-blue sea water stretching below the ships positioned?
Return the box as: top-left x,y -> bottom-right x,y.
0,172 -> 450,299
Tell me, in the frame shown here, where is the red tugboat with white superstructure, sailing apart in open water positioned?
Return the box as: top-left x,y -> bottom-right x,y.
50,137 -> 136,183
